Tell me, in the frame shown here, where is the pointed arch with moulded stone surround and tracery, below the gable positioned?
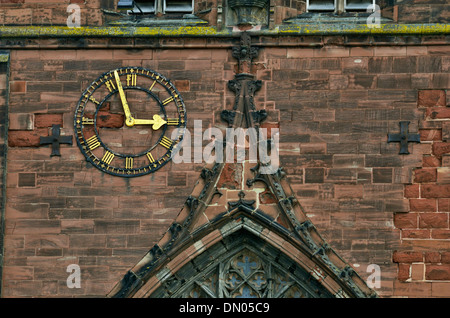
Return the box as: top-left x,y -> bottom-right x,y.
133,211 -> 367,298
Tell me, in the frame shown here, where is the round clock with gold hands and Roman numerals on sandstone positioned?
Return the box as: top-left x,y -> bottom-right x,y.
74,67 -> 186,177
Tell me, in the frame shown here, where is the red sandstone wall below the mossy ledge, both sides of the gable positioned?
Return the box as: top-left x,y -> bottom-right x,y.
3,42 -> 450,297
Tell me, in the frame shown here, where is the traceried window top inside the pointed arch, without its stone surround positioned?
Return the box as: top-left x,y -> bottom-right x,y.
150,229 -> 334,298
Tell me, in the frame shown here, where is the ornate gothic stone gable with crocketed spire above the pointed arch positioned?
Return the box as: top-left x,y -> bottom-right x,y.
108,33 -> 376,298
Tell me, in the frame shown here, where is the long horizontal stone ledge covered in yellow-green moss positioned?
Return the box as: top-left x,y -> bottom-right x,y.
0,23 -> 450,38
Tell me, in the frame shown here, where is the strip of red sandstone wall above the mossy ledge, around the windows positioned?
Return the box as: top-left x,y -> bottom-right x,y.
0,0 -> 442,26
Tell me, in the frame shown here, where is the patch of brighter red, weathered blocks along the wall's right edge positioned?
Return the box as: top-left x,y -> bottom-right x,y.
393,89 -> 450,297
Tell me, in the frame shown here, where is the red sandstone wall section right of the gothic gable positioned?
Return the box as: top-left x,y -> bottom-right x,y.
258,46 -> 450,296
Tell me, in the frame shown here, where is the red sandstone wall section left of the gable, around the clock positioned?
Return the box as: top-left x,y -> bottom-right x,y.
3,50 -> 231,297
